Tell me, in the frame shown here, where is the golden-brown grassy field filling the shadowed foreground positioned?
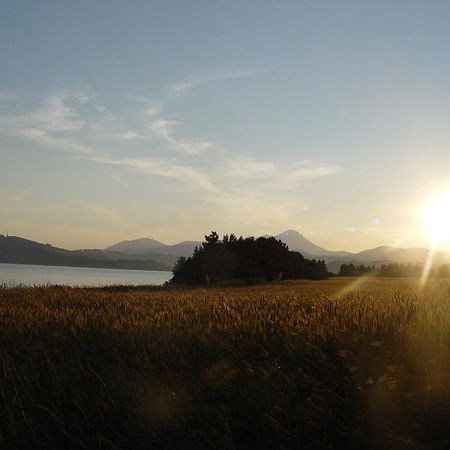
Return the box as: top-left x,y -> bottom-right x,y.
0,278 -> 450,449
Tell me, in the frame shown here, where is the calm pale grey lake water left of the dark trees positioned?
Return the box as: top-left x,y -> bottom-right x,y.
0,263 -> 172,286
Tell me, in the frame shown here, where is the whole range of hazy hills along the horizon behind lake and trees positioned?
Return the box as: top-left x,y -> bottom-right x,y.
4,230 -> 450,273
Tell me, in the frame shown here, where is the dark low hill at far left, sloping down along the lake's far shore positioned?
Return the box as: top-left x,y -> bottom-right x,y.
0,235 -> 172,270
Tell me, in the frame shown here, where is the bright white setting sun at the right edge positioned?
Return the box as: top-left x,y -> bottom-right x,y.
424,188 -> 450,247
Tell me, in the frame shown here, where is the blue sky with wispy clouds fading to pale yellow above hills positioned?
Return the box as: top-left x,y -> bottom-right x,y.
0,0 -> 450,251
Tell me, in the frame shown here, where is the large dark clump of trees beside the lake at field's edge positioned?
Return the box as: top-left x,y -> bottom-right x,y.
171,231 -> 328,284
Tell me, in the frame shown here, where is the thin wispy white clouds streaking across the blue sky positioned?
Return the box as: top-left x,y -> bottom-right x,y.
0,81 -> 342,237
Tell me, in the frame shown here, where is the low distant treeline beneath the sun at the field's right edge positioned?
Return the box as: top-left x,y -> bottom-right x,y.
338,263 -> 450,278
